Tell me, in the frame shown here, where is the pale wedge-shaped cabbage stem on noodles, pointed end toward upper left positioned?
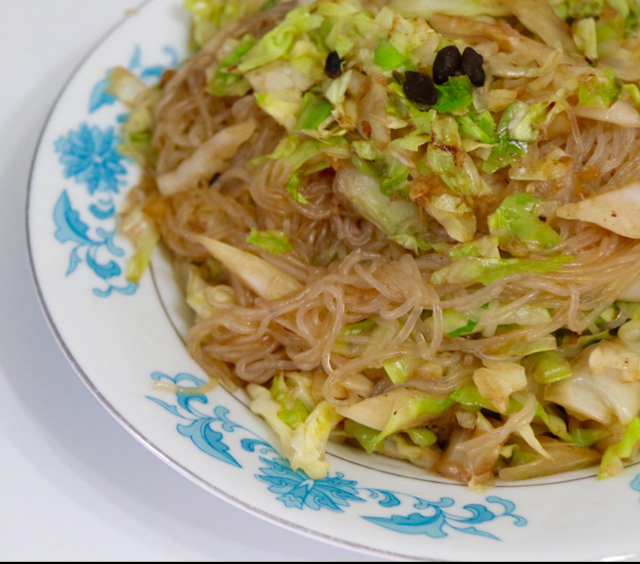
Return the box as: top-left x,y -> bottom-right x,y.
193,235 -> 303,300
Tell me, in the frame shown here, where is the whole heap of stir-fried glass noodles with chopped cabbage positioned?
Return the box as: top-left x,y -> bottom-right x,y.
114,0 -> 640,488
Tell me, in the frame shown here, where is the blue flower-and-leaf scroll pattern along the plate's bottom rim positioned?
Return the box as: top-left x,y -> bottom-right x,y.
147,372 -> 527,540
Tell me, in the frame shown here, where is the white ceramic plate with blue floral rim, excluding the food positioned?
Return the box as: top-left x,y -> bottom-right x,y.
27,0 -> 640,561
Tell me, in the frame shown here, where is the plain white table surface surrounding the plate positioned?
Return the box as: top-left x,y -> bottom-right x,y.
0,0 -> 384,561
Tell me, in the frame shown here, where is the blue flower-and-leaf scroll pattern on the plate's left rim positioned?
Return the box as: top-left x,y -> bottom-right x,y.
53,46 -> 179,298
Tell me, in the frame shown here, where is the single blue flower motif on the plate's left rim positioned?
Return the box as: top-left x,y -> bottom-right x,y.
55,123 -> 127,194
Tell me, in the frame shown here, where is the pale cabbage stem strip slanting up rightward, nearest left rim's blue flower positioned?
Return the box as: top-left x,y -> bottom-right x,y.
157,121 -> 256,196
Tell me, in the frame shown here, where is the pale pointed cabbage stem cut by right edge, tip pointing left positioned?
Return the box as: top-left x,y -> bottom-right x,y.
557,181 -> 640,239
